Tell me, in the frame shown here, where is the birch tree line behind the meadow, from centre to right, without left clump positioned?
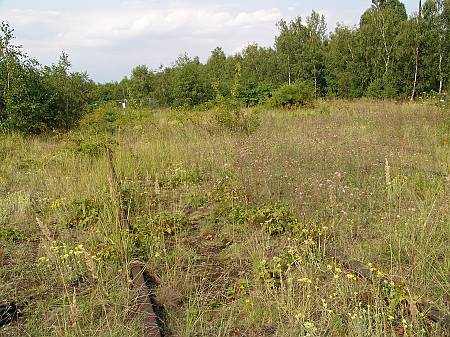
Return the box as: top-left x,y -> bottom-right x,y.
99,0 -> 450,106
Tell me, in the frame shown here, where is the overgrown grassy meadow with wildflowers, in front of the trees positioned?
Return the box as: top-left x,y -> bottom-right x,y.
0,100 -> 450,337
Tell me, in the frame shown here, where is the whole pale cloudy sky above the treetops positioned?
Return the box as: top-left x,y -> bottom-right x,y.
0,0 -> 418,82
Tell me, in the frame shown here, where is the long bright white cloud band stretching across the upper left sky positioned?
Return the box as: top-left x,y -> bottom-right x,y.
6,8 -> 281,48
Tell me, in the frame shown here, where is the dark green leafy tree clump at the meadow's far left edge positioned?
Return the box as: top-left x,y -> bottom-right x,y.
0,22 -> 94,133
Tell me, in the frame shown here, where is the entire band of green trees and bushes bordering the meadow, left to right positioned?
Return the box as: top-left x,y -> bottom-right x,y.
0,0 -> 450,133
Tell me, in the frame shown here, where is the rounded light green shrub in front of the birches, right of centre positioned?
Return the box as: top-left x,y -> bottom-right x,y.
272,81 -> 314,107
